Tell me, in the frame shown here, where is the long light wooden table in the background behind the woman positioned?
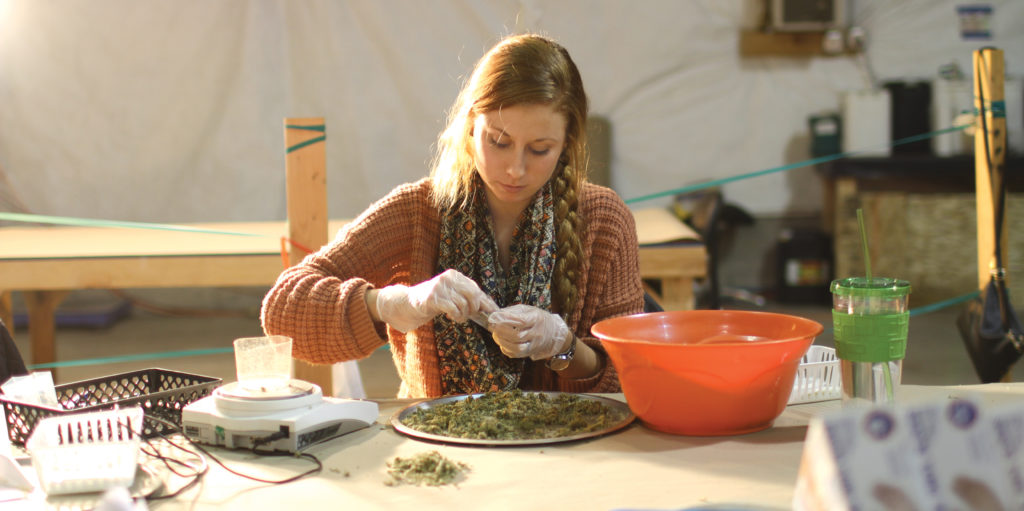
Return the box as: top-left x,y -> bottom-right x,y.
0,220 -> 707,372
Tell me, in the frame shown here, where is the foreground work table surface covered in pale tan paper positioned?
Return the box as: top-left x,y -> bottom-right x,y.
5,383 -> 1024,511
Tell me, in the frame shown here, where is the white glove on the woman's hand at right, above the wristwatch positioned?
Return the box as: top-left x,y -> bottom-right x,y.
487,304 -> 571,360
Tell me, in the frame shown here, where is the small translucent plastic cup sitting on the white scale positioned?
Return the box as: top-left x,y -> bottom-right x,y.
234,335 -> 292,392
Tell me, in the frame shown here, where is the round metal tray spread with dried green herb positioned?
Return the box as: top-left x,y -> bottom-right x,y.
401,390 -> 628,440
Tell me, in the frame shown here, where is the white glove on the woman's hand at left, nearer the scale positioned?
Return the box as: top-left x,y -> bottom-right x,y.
377,269 -> 498,333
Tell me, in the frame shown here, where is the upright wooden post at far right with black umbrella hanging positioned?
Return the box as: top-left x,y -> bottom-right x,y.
974,48 -> 1013,382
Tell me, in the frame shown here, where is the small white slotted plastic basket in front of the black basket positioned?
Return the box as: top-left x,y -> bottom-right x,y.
26,407 -> 143,495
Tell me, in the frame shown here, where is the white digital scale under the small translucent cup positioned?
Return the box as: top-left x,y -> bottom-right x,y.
181,380 -> 379,453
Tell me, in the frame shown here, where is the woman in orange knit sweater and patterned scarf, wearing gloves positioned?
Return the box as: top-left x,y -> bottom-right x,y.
261,35 -> 643,397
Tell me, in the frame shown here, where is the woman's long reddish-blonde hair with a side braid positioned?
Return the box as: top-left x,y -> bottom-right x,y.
430,34 -> 588,316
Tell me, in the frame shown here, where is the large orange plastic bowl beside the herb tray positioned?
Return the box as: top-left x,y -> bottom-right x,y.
592,310 -> 823,436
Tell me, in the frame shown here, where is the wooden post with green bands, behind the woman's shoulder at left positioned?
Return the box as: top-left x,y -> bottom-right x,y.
285,117 -> 334,395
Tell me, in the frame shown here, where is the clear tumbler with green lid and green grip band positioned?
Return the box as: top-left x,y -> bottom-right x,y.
830,276 -> 910,402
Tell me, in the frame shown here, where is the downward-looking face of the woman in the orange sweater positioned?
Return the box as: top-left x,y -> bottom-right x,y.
473,104 -> 566,215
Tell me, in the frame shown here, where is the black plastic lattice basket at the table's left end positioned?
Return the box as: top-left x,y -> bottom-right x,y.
0,369 -> 221,445
